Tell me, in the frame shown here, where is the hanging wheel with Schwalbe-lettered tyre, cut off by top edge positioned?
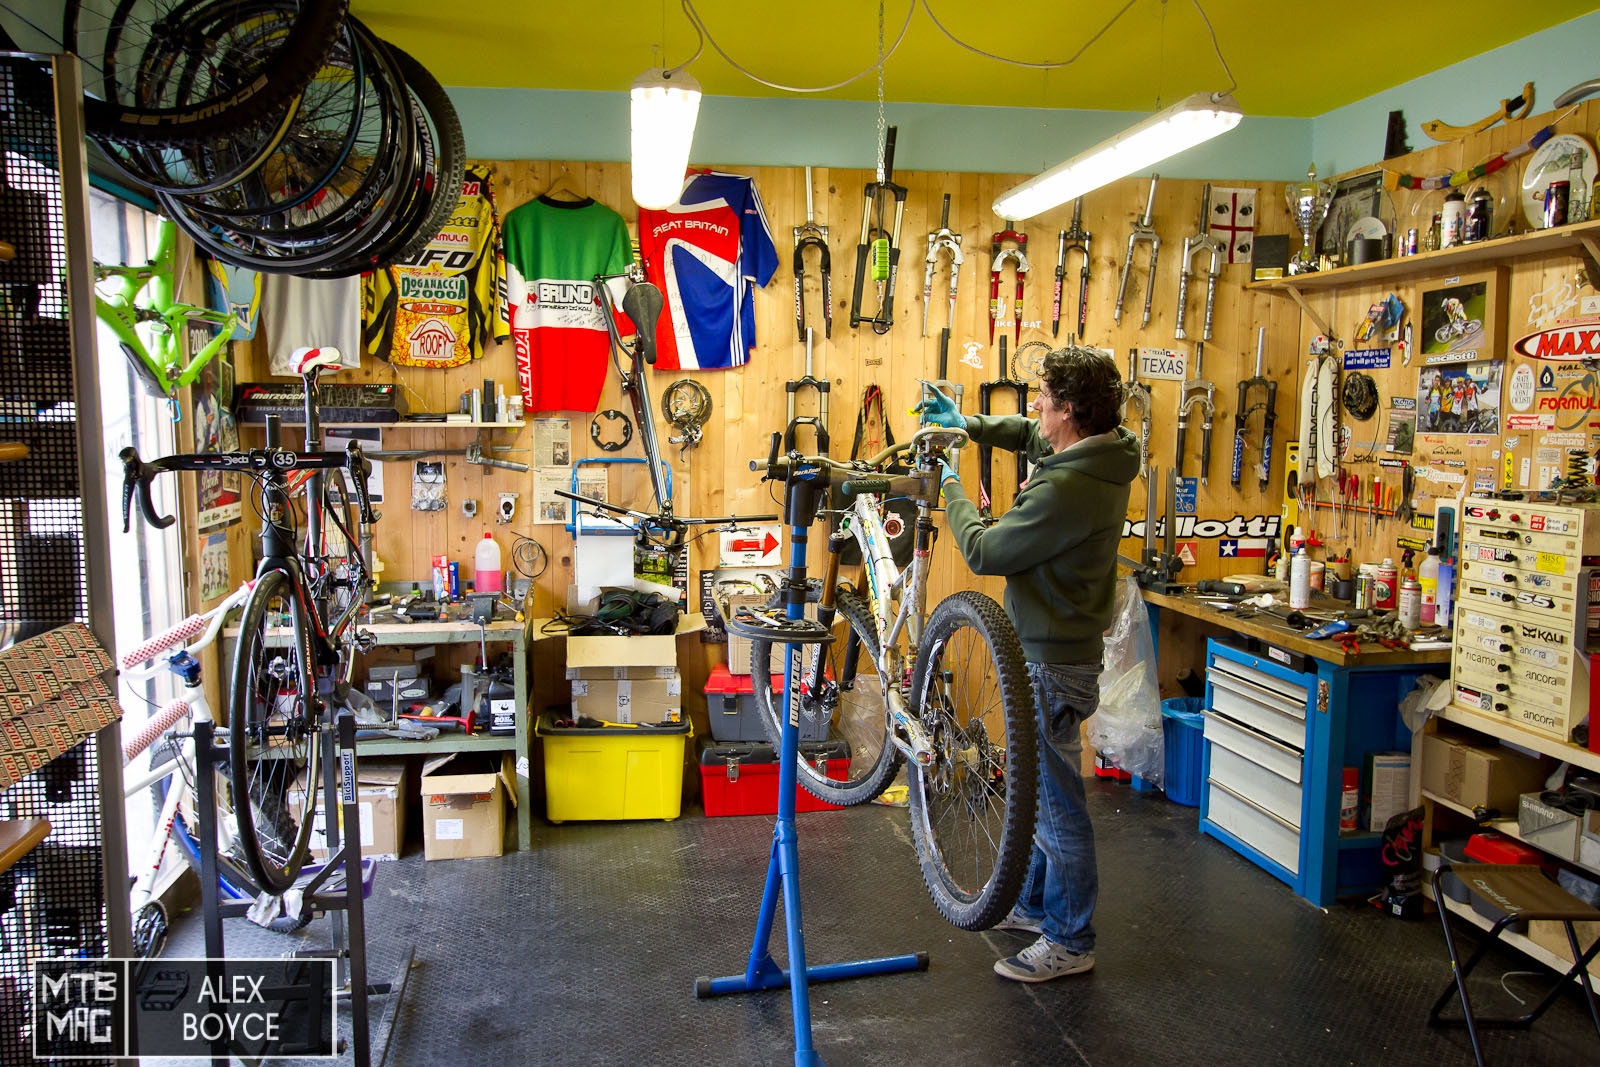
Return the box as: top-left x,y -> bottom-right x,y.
61,0 -> 349,144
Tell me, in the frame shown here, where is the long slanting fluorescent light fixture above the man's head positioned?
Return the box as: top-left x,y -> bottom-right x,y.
994,93 -> 1245,219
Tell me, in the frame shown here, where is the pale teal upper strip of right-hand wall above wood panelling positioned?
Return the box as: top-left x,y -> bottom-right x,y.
1312,11 -> 1600,174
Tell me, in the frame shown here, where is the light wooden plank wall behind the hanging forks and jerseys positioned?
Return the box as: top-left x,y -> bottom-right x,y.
181,93 -> 1600,716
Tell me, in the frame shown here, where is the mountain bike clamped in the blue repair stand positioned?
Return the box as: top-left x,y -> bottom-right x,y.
739,426 -> 1038,929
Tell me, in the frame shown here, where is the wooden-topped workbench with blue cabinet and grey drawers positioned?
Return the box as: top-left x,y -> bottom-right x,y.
1144,592 -> 1450,905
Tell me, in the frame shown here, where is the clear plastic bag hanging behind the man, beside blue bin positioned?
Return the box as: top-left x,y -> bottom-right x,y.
1088,577 -> 1166,785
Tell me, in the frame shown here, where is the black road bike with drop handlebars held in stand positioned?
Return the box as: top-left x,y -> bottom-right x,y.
120,349 -> 373,893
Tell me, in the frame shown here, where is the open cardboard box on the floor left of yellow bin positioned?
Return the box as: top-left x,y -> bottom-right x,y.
421,753 -> 517,859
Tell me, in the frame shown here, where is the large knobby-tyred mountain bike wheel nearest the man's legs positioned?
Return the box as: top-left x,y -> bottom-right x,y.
907,592 -> 1038,929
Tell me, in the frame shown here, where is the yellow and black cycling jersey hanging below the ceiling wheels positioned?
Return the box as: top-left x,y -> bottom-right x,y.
362,168 -> 510,366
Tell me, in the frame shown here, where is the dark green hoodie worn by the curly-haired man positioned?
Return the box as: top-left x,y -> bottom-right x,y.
944,414 -> 1139,664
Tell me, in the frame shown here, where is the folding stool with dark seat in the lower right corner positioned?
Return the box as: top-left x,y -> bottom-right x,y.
1427,864 -> 1600,1067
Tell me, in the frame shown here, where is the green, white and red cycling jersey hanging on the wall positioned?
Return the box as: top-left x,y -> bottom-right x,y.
506,197 -> 634,413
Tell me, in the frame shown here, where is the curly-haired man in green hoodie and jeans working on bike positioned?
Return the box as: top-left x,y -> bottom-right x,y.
920,347 -> 1139,982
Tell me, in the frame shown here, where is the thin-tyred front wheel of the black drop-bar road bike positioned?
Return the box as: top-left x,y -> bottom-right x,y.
227,571 -> 320,893
